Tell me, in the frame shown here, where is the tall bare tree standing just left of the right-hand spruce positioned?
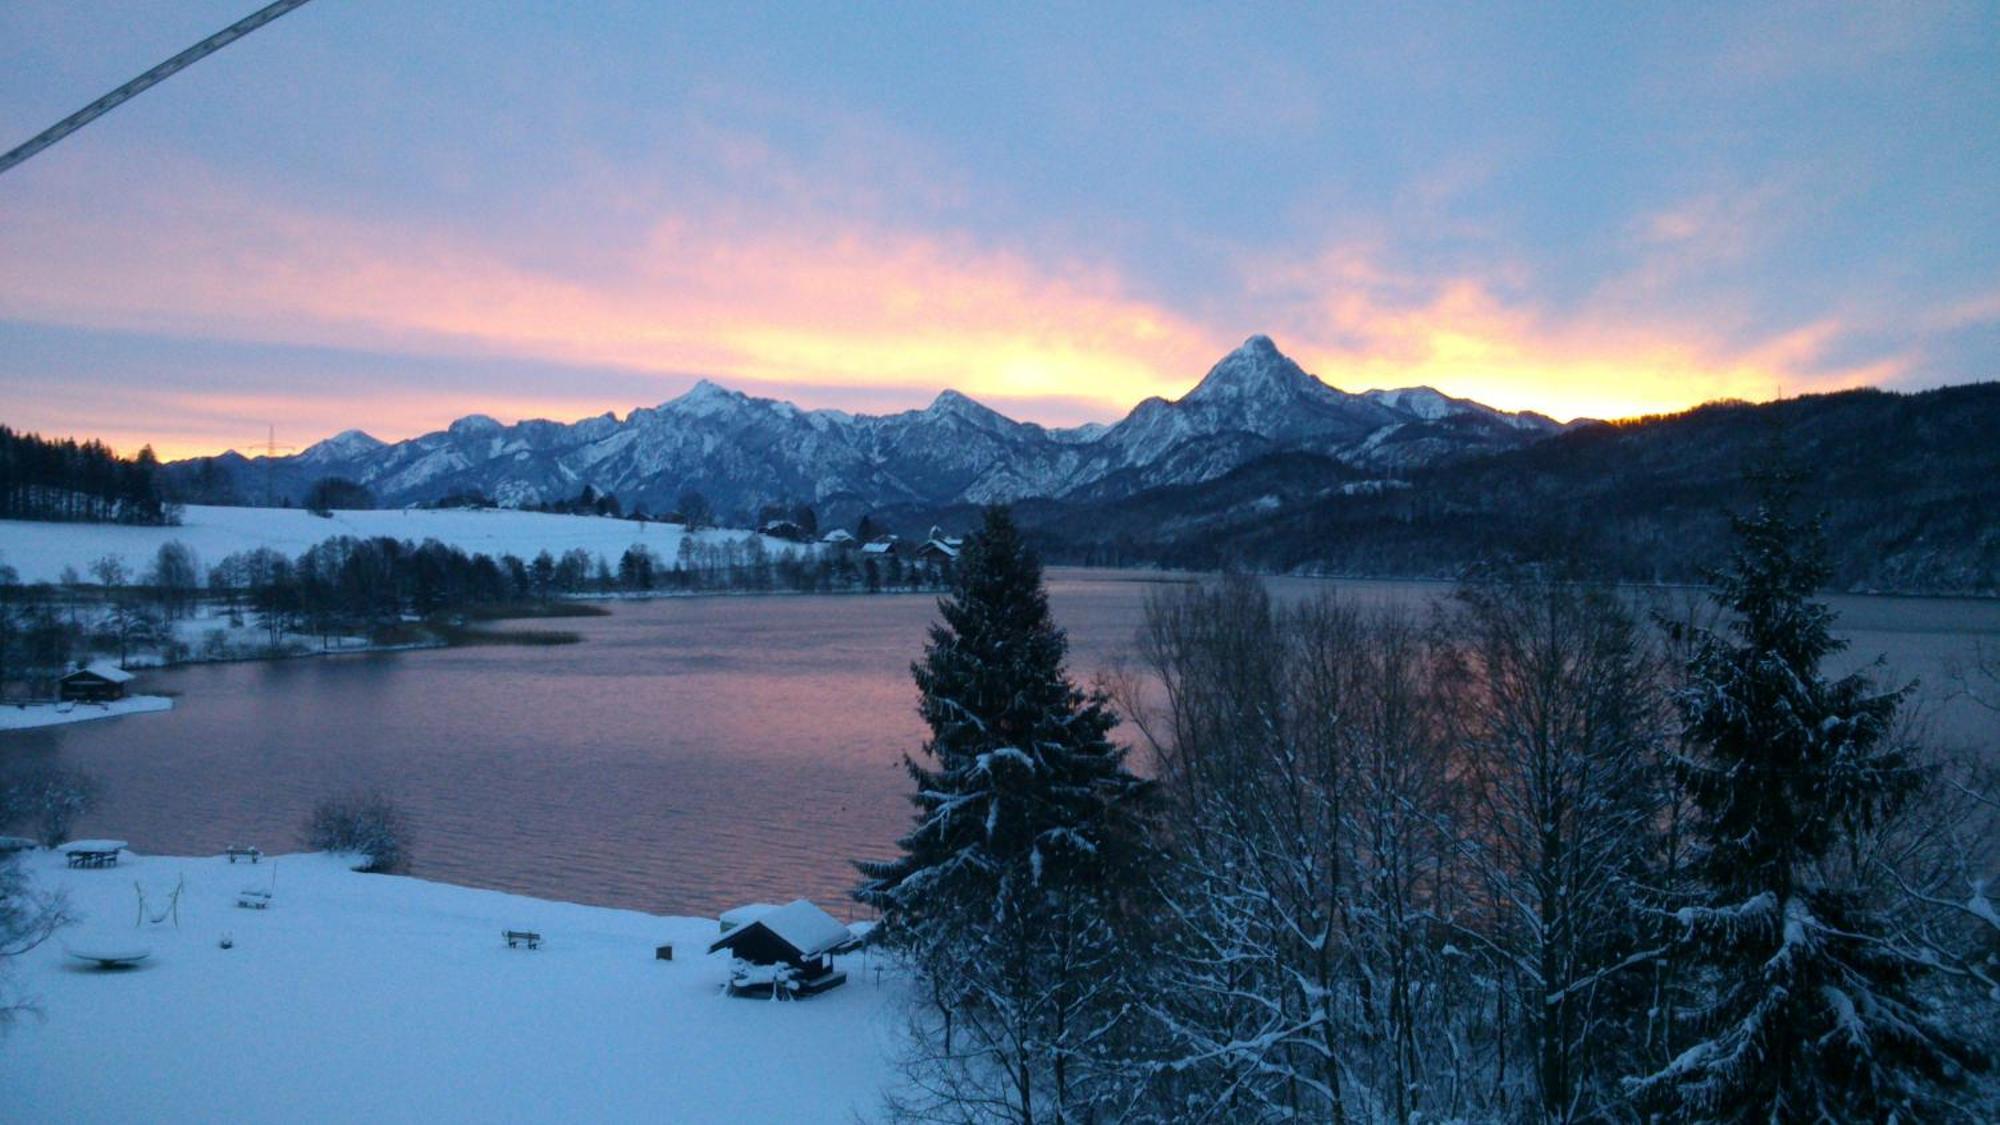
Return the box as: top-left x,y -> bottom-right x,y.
1444,579 -> 1668,1121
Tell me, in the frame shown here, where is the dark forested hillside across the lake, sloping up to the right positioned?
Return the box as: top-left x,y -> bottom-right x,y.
1024,382 -> 2000,593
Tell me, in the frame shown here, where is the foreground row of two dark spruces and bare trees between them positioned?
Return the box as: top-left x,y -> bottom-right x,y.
856,500 -> 2000,1123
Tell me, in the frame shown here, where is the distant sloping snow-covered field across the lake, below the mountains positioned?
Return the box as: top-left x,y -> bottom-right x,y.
0,504 -> 794,583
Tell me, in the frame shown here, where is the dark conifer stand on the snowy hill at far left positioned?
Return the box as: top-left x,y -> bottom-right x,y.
0,426 -> 180,524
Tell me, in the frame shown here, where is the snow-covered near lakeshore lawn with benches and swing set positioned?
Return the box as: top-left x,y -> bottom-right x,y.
0,853 -> 900,1123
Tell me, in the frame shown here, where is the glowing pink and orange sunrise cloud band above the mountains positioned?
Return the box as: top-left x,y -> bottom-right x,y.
0,155 -> 1904,458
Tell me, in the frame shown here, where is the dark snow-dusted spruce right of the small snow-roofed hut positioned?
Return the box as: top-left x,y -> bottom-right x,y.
856,506 -> 1148,1123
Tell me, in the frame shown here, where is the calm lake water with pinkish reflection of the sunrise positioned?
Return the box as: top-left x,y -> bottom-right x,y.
0,571 -> 2000,915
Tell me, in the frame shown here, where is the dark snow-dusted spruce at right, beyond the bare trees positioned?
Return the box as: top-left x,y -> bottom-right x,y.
1632,476 -> 1974,1123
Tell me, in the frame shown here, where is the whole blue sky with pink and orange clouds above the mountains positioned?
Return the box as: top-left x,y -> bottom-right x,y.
0,0 -> 2000,456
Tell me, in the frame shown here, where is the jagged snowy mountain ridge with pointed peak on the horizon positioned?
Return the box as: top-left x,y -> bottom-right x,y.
168,336 -> 1562,518
